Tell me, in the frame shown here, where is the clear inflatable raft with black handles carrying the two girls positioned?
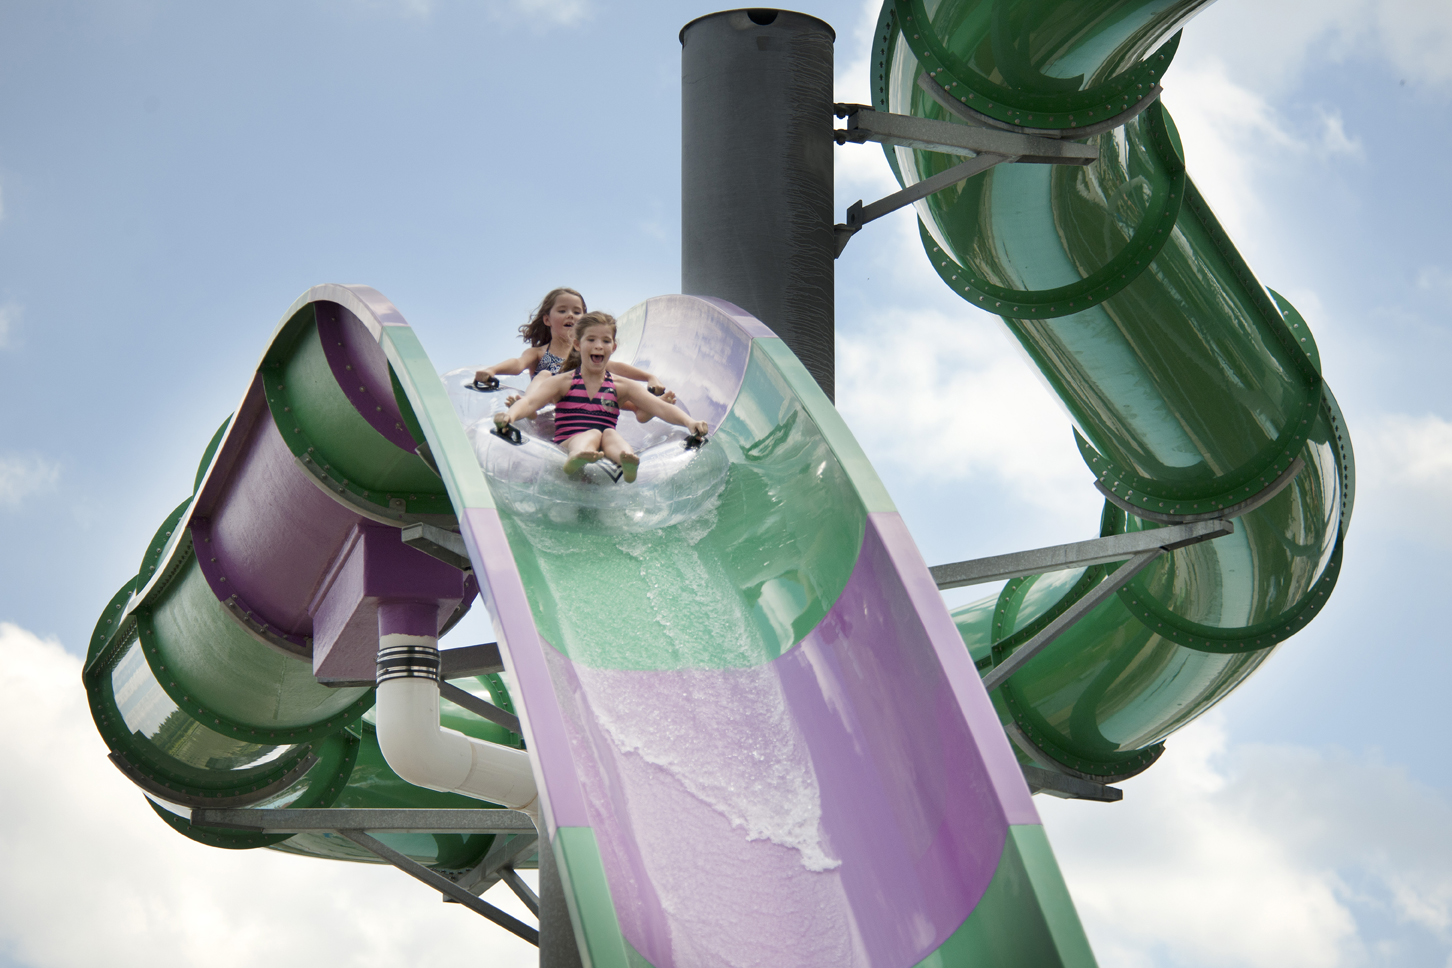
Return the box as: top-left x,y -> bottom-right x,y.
443,367 -> 730,531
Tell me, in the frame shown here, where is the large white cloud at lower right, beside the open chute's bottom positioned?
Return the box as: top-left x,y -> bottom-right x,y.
1035,714 -> 1452,968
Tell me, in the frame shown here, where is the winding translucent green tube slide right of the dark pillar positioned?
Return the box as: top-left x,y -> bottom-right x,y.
873,0 -> 1355,781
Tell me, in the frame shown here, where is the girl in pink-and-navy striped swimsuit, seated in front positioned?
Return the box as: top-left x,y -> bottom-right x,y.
494,312 -> 707,483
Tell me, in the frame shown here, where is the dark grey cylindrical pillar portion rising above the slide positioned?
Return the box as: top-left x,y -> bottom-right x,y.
681,9 -> 836,396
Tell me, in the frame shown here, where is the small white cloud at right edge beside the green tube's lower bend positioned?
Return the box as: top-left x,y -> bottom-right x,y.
1352,414 -> 1452,544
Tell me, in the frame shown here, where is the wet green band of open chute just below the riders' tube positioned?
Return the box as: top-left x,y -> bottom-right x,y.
501,340 -> 865,669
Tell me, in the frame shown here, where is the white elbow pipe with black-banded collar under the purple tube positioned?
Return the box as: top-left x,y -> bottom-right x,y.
378,634 -> 539,826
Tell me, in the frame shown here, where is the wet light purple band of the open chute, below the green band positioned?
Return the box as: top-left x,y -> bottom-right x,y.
530,514 -> 1038,968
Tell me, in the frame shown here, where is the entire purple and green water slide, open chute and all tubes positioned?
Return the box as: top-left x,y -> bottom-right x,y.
76,0 -> 1353,968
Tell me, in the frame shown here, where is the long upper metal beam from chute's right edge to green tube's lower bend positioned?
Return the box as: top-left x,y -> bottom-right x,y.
929,521 -> 1236,589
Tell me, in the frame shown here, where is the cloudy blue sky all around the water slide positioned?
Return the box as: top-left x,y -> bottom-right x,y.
0,0 -> 1452,968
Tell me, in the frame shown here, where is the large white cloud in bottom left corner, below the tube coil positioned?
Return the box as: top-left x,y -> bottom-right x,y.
0,623 -> 537,968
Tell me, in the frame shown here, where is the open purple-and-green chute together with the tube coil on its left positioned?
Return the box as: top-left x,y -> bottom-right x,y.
87,286 -> 1092,965
